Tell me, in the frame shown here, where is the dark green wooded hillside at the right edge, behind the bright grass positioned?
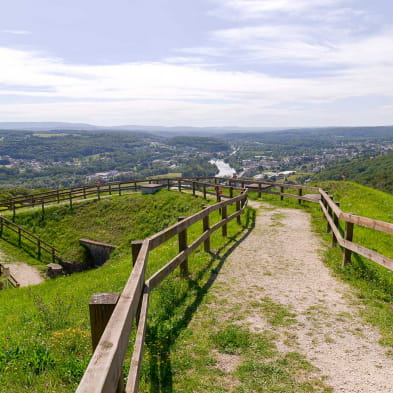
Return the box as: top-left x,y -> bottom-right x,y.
314,152 -> 393,194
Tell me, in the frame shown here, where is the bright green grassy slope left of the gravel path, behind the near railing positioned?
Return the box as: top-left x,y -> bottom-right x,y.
0,191 -> 248,392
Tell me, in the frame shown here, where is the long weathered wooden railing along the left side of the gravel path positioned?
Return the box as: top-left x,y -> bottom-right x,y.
77,187 -> 247,393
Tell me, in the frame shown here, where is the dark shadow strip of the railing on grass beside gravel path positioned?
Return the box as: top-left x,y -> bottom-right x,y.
146,209 -> 256,393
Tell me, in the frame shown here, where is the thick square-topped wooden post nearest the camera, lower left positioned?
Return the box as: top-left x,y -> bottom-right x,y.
89,293 -> 124,393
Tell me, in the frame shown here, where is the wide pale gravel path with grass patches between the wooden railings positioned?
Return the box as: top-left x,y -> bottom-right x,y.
216,202 -> 393,393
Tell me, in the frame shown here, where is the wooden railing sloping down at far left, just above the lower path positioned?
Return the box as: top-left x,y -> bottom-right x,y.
0,215 -> 61,262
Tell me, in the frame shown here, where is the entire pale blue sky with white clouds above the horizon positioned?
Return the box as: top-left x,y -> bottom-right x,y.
0,0 -> 393,127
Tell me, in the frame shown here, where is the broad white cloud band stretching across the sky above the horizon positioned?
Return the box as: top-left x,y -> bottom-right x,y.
0,48 -> 393,126
